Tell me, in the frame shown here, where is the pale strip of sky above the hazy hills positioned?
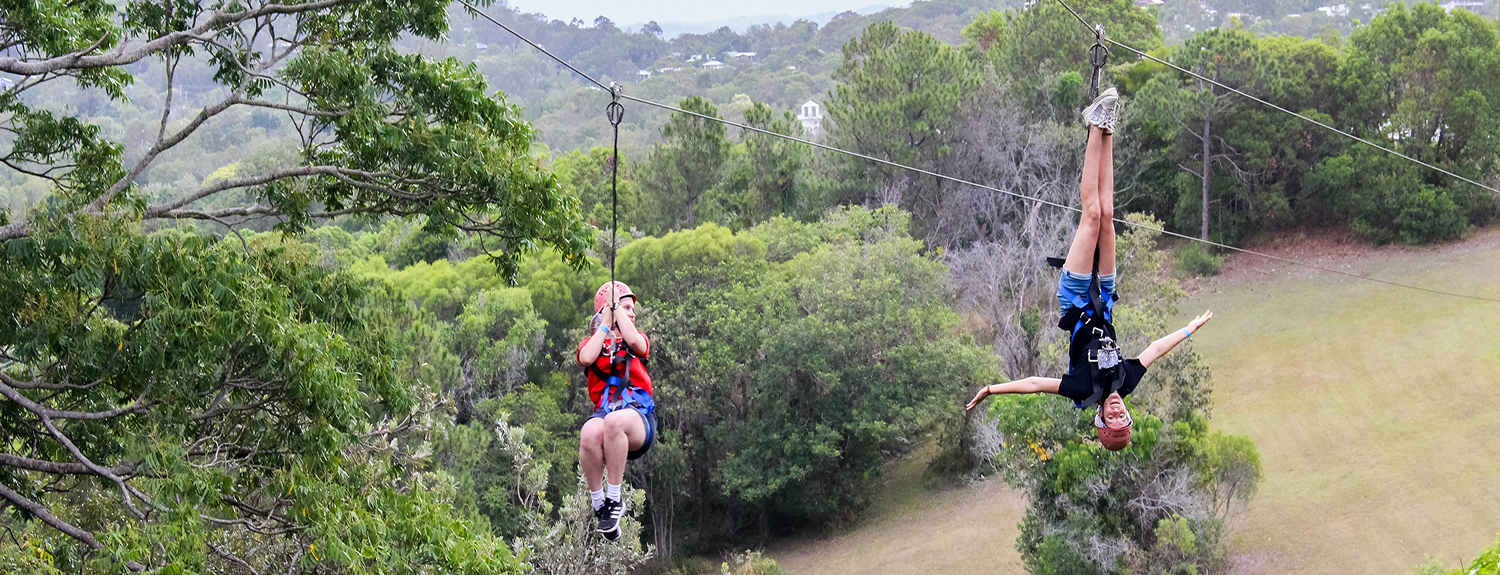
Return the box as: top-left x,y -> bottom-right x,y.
507,0 -> 911,29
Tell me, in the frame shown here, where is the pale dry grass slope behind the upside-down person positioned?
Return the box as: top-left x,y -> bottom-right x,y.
767,230 -> 1500,575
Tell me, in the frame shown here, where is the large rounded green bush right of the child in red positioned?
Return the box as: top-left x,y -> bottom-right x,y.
621,209 -> 998,543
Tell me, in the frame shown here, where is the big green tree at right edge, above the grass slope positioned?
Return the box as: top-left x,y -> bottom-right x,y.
1331,5 -> 1500,242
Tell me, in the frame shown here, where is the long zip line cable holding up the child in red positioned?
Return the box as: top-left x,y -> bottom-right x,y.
461,9 -> 1500,303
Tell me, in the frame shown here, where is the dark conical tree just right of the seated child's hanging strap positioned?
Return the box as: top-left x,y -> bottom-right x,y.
642,96 -> 731,230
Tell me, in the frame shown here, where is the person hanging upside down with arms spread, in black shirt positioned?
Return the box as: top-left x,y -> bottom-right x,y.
966,89 -> 1214,450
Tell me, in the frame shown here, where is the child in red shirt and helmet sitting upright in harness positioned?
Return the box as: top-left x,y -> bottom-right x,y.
578,282 -> 657,540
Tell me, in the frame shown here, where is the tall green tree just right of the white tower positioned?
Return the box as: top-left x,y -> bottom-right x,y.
827,23 -> 980,234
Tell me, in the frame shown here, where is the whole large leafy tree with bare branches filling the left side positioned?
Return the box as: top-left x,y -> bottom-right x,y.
0,0 -> 590,573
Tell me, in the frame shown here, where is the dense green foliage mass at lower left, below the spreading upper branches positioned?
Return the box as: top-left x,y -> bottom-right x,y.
0,218 -> 519,573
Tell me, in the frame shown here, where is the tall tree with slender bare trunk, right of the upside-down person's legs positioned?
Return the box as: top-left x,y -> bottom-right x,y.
1139,29 -> 1280,240
